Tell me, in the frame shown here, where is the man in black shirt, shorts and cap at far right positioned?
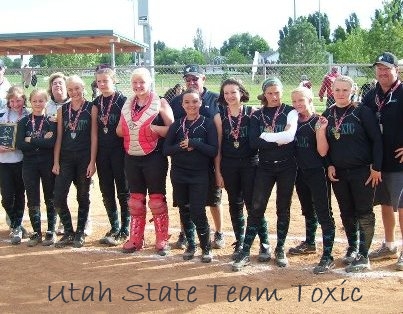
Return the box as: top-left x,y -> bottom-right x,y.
362,52 -> 403,271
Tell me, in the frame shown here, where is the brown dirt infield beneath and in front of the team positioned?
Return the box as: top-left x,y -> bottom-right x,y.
0,178 -> 403,313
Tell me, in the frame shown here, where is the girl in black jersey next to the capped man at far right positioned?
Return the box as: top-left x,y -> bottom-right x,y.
318,76 -> 383,272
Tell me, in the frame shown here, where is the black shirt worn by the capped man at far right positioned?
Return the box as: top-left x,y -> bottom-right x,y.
362,81 -> 403,172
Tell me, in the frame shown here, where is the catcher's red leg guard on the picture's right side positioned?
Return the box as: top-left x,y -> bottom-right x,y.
148,194 -> 169,252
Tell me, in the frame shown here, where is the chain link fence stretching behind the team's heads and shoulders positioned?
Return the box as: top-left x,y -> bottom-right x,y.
6,64 -> 374,112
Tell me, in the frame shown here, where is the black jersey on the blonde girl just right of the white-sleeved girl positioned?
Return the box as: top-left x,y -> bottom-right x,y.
295,114 -> 325,169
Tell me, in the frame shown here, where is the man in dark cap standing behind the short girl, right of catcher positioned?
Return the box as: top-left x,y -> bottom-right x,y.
170,64 -> 225,249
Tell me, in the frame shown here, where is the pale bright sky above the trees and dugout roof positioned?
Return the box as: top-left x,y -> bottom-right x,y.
0,0 -> 383,49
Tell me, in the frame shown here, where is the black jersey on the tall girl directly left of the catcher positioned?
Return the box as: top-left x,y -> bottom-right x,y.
93,92 -> 127,148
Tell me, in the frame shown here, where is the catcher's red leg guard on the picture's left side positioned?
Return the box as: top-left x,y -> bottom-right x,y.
123,193 -> 146,253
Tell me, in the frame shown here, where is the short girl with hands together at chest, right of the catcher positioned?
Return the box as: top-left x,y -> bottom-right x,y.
164,89 -> 218,263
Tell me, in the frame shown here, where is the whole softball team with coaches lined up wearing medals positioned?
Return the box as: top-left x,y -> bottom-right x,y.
0,53 -> 403,274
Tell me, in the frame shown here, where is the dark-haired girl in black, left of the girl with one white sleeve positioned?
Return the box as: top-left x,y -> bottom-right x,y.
218,79 -> 269,262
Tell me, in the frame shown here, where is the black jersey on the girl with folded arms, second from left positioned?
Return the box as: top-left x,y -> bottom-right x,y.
16,114 -> 57,160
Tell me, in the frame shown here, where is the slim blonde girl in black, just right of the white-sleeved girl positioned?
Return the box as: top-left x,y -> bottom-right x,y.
289,87 -> 335,274
